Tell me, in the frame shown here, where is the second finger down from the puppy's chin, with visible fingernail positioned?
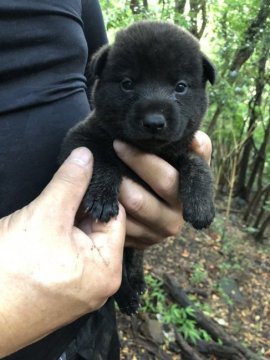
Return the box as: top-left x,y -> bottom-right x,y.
119,178 -> 182,236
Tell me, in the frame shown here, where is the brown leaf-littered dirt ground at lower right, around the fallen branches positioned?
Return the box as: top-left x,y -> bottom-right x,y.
118,205 -> 270,360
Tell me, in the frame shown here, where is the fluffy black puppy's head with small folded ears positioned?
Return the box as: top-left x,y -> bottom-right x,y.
90,21 -> 215,148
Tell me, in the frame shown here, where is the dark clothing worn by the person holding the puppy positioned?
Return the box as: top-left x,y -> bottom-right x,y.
0,0 -> 118,360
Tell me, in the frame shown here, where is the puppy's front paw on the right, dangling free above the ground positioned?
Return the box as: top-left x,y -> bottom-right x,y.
183,198 -> 215,230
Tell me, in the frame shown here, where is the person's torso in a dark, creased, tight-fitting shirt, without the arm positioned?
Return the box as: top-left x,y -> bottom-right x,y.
0,0 -> 89,217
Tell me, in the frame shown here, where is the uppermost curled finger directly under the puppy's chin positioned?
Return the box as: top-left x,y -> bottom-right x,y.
114,141 -> 179,205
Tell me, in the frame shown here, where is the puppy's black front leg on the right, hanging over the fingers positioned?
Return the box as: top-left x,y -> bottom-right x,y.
179,153 -> 215,229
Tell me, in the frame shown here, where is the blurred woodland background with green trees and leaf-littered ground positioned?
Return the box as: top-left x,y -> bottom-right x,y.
97,0 -> 270,360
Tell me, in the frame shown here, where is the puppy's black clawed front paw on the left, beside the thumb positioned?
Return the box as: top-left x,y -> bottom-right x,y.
83,187 -> 119,222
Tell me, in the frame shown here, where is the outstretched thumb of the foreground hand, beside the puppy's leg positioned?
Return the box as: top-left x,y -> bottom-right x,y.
38,147 -> 93,225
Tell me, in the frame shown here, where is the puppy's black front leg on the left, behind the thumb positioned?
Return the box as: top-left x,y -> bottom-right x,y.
60,126 -> 122,222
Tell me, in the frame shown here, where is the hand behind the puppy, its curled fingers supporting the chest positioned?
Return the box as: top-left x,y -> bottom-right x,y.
114,131 -> 212,249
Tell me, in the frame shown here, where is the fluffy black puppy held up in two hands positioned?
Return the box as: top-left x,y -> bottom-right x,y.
60,21 -> 215,314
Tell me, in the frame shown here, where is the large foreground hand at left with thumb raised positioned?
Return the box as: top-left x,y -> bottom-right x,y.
0,148 -> 125,358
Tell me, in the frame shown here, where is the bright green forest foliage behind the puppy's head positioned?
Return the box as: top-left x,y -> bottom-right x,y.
101,0 -> 270,236
